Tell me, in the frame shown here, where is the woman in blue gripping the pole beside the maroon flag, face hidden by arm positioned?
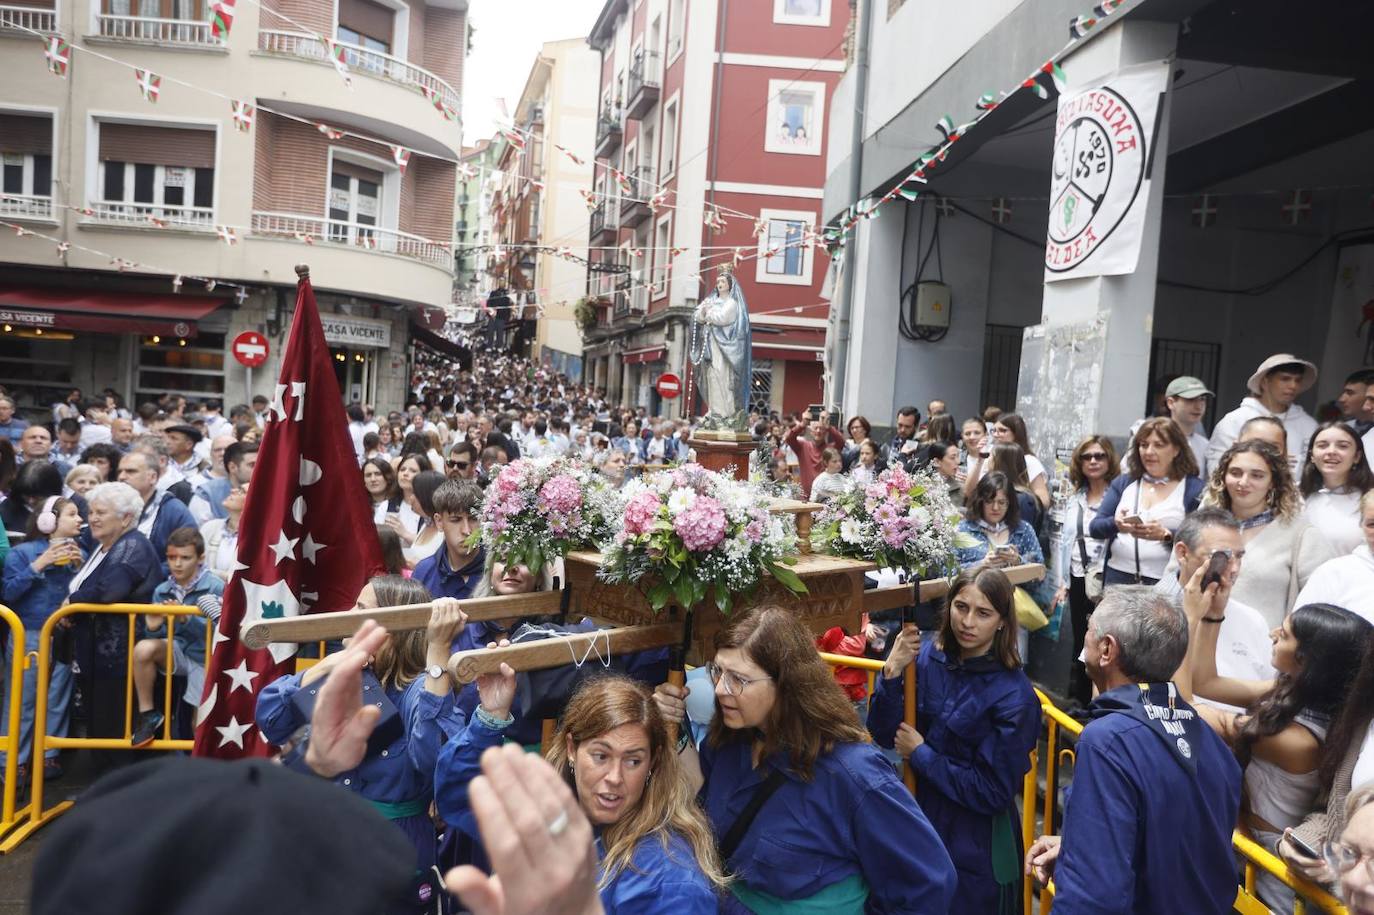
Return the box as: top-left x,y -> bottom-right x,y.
256,576 -> 467,912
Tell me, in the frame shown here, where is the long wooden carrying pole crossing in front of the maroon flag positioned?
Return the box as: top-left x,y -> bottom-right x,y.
242,591 -> 563,648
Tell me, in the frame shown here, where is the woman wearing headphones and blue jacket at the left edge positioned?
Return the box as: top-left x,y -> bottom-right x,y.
0,496 -> 85,783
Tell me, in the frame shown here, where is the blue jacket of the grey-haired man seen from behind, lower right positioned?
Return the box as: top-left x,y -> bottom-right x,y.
1054,684 -> 1241,915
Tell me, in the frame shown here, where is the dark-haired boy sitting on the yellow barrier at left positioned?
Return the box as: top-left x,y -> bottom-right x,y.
133,528 -> 224,747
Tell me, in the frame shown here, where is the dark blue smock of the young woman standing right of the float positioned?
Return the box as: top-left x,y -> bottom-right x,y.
868,642 -> 1040,912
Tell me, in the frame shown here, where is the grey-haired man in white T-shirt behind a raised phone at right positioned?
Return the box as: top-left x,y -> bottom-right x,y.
1154,508 -> 1276,712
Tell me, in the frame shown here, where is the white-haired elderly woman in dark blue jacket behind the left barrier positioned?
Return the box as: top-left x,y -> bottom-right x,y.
68,482 -> 162,767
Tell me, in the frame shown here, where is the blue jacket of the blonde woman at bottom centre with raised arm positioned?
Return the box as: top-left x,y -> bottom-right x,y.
434,717 -> 720,915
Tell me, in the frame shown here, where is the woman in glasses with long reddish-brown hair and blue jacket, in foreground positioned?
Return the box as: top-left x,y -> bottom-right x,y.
654,606 -> 956,915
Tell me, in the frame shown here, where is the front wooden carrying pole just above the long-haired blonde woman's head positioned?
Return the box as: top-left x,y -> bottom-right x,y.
448,622 -> 683,683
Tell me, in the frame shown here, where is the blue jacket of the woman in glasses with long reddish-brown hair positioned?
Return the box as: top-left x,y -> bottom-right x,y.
701,741 -> 955,915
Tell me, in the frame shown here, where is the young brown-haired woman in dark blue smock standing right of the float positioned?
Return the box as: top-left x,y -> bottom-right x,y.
868,569 -> 1040,915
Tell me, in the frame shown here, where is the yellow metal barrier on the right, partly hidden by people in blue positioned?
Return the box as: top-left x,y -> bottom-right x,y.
820,651 -> 1348,915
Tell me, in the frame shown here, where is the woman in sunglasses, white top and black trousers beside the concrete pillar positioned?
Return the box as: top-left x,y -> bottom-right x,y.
1054,436 -> 1117,706
